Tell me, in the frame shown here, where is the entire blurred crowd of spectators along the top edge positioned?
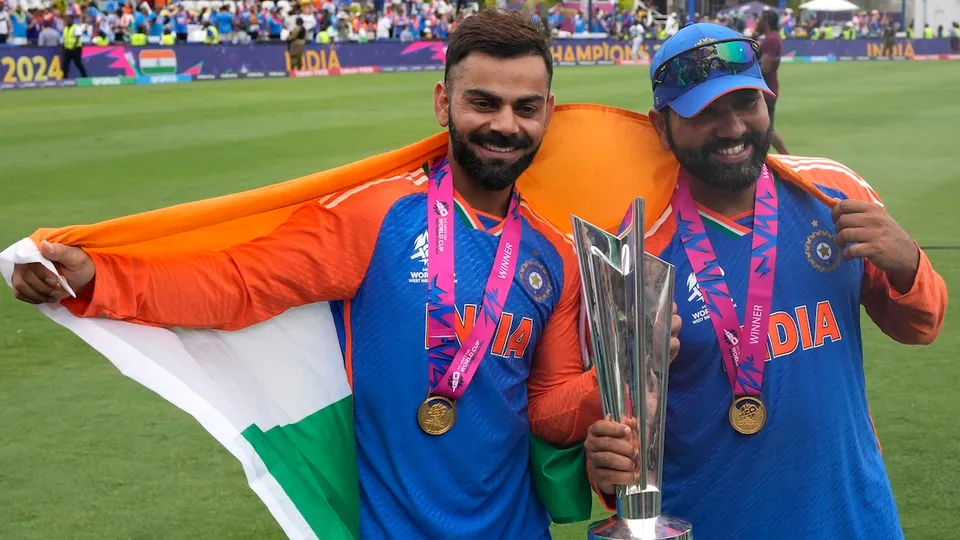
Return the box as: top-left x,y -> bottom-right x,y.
0,0 -> 960,45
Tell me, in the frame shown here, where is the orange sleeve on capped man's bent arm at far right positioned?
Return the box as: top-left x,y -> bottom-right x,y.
788,158 -> 947,345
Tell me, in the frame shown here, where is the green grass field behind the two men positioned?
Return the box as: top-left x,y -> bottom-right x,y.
0,62 -> 960,540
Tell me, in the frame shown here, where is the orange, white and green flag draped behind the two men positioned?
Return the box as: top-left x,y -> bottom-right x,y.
0,106 -> 796,540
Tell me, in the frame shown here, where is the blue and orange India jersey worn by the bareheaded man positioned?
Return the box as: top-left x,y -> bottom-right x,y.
65,165 -> 600,540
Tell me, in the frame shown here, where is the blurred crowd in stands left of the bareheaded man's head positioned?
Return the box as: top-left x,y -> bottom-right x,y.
0,0 -> 488,44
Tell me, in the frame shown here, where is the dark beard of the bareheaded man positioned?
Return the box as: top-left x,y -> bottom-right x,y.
449,115 -> 540,191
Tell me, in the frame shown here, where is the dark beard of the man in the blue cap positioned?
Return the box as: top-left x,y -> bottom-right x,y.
667,122 -> 773,191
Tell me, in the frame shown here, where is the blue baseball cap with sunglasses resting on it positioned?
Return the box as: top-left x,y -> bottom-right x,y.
650,23 -> 775,118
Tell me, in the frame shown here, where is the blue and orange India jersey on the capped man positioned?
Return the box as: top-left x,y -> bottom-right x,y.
608,160 -> 945,540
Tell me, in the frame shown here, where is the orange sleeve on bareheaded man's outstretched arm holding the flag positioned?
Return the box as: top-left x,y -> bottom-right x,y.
62,173 -> 425,330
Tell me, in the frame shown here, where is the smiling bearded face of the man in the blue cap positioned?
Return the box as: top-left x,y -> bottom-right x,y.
650,89 -> 772,191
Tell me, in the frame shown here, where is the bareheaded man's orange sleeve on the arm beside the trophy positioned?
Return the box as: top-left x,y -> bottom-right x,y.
527,202 -> 602,447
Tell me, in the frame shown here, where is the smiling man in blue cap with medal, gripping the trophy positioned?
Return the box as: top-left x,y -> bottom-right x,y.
585,23 -> 947,540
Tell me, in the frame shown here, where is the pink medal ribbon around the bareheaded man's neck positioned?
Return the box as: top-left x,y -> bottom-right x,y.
427,158 -> 522,400
